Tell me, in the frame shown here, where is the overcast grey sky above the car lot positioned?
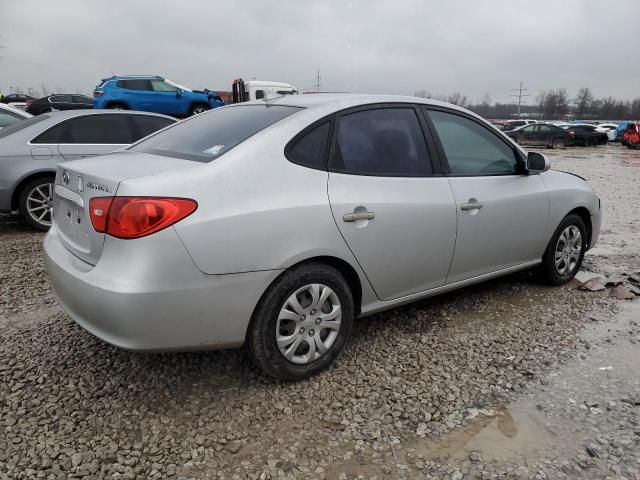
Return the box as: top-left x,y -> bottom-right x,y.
0,0 -> 640,103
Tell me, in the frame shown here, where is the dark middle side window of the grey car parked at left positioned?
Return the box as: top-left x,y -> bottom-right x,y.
60,114 -> 133,145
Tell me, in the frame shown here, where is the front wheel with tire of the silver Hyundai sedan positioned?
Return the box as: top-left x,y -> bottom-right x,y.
540,213 -> 587,285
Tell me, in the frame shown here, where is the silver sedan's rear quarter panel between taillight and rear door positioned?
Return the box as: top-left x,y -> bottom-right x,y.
118,109 -> 375,300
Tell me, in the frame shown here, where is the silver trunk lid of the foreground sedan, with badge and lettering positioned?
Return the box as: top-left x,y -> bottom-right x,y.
53,152 -> 201,265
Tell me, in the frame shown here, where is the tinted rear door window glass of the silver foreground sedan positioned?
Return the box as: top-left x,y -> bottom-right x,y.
331,107 -> 433,177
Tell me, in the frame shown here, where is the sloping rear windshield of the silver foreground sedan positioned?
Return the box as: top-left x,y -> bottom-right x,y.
130,105 -> 300,162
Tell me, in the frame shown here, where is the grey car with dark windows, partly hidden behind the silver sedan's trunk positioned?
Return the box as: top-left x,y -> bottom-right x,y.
0,110 -> 176,230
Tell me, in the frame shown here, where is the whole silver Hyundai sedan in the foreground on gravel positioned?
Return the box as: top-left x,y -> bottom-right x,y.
44,94 -> 601,380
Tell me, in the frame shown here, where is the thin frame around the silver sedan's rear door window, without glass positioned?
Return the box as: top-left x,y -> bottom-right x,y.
327,102 -> 442,178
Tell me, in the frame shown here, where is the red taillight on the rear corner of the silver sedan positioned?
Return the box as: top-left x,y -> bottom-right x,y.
89,197 -> 198,239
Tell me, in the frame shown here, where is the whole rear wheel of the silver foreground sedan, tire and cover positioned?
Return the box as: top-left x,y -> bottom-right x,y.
246,263 -> 354,381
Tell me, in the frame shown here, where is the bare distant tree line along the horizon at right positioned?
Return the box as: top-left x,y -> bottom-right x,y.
415,87 -> 640,120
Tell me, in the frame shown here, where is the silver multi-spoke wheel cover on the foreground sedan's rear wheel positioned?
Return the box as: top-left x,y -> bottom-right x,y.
276,283 -> 342,365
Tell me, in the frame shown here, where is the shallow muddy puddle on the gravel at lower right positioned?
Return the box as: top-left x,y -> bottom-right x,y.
398,301 -> 640,465
